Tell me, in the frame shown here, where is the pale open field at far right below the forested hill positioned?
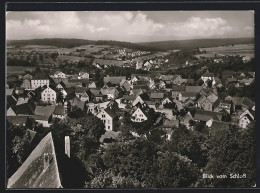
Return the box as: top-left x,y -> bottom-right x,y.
195,44 -> 255,58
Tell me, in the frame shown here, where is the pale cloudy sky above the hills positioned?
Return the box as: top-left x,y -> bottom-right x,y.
6,11 -> 254,42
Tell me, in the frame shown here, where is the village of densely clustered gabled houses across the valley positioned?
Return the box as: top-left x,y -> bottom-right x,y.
6,49 -> 255,140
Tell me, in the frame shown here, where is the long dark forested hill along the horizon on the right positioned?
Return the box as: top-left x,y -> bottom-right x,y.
138,38 -> 254,50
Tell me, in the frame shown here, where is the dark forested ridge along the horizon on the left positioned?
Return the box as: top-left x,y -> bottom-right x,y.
7,38 -> 164,51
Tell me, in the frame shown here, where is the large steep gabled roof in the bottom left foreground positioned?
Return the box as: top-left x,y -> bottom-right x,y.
7,132 -> 62,188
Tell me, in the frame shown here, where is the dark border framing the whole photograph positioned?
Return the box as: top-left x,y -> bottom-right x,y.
0,1 -> 260,192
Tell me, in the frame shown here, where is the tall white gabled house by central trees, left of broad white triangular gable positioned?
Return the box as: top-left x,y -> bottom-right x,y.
96,107 -> 116,131
